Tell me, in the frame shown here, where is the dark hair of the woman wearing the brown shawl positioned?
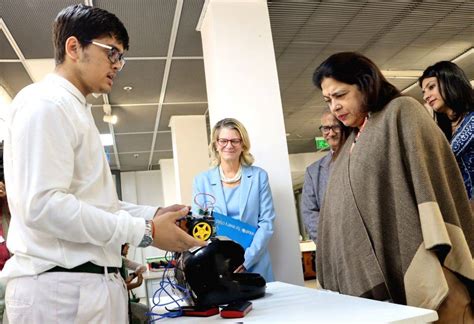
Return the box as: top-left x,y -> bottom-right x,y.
313,52 -> 401,112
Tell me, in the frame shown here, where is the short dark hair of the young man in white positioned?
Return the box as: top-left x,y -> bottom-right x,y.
53,4 -> 129,65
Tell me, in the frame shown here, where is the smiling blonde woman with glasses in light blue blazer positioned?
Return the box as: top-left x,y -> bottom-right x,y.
193,118 -> 275,282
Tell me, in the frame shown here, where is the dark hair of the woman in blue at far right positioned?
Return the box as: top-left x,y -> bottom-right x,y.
418,61 -> 474,121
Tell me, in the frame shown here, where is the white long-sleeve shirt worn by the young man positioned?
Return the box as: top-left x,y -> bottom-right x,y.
1,74 -> 156,278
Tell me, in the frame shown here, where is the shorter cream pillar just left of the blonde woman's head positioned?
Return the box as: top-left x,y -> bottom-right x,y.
169,116 -> 209,205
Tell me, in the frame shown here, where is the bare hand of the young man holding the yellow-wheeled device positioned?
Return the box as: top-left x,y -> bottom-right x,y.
152,209 -> 207,252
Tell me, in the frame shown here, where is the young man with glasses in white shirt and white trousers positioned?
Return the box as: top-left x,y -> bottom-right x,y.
1,4 -> 204,323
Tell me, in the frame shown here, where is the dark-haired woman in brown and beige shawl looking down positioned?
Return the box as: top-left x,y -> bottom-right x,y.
313,52 -> 474,323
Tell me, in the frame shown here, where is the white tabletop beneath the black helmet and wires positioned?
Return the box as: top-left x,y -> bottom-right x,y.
151,282 -> 438,324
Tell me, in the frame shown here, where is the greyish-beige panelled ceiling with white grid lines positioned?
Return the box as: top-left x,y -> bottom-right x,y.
0,0 -> 474,171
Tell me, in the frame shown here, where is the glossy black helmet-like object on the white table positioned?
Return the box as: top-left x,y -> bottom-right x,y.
175,237 -> 266,307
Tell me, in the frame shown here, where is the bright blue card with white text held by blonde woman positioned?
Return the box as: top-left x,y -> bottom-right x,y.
212,211 -> 257,250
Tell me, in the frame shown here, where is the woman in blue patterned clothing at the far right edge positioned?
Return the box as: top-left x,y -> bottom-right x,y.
418,61 -> 474,201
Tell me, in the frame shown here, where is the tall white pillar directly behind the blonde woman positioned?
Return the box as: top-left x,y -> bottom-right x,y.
201,0 -> 303,285
